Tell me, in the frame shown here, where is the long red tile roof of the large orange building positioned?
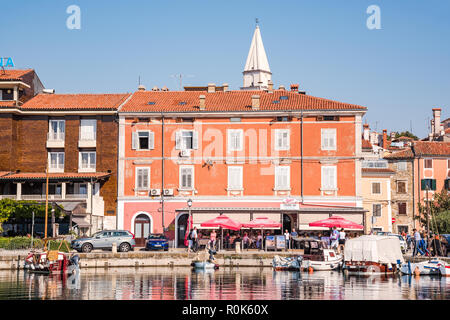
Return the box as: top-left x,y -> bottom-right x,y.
119,90 -> 367,113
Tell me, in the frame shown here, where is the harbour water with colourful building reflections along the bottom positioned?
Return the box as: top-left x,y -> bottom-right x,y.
0,268 -> 450,300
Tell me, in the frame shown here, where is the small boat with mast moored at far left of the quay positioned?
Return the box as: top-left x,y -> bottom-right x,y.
23,250 -> 80,274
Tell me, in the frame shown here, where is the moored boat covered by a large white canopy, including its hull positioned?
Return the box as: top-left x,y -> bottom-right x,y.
343,235 -> 404,275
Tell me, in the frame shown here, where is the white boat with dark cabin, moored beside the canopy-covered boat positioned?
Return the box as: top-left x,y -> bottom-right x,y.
296,238 -> 343,271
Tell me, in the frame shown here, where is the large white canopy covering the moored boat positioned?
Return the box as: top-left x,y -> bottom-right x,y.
344,235 -> 404,264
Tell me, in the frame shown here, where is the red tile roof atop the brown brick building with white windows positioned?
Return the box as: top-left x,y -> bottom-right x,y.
20,93 -> 131,110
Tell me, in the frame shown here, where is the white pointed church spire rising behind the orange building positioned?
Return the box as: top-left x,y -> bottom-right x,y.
241,20 -> 272,90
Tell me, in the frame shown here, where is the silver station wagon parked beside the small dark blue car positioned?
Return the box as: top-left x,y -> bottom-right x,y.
71,230 -> 136,252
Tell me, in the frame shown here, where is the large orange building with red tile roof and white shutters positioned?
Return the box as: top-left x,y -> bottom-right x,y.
118,85 -> 366,245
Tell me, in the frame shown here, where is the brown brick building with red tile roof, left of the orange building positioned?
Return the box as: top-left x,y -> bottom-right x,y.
0,85 -> 129,232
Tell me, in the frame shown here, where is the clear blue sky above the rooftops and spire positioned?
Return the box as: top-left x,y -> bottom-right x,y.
0,0 -> 450,137
